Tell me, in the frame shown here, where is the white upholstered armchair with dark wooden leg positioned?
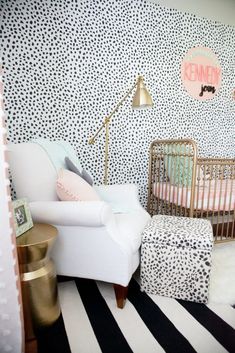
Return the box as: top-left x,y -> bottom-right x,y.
9,142 -> 150,308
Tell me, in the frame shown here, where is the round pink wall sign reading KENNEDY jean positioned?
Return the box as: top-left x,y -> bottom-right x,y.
181,47 -> 221,100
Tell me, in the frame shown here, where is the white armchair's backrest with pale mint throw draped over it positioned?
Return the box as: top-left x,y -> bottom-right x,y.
9,139 -> 82,201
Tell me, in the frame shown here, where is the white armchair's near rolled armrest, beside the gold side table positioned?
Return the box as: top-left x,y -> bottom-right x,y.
29,201 -> 113,227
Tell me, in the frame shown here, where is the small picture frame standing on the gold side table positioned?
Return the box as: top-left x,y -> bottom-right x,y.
12,199 -> 33,237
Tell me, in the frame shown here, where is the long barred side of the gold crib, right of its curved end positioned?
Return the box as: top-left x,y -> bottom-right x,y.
193,158 -> 235,242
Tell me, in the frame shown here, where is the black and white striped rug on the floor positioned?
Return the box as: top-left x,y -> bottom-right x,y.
38,278 -> 235,353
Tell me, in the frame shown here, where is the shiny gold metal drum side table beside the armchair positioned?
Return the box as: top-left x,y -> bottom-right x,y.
16,224 -> 60,339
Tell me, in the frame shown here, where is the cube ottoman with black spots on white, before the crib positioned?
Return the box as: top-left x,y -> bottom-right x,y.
140,215 -> 213,303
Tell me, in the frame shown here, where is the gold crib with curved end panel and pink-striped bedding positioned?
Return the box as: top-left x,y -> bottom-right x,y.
148,139 -> 235,242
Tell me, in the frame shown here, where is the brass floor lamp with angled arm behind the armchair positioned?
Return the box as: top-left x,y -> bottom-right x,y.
88,76 -> 153,184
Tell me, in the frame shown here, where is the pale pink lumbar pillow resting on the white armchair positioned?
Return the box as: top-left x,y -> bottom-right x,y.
56,169 -> 100,201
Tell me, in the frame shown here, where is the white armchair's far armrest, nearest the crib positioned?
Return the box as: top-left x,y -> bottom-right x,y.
95,184 -> 142,213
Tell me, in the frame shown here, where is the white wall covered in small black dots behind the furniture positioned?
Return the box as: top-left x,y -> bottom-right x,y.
0,0 -> 235,203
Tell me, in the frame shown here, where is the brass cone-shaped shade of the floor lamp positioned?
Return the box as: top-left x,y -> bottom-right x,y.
132,76 -> 153,109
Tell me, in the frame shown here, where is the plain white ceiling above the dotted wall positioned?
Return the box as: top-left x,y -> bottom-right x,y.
148,0 -> 235,26
